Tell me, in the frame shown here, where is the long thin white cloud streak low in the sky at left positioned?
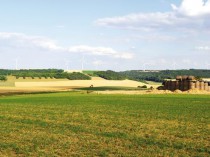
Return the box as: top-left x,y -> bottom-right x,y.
0,32 -> 132,59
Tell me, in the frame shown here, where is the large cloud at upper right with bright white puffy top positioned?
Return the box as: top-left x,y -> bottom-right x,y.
96,0 -> 210,31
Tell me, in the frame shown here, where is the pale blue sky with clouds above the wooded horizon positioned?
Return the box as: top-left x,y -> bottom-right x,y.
0,0 -> 210,71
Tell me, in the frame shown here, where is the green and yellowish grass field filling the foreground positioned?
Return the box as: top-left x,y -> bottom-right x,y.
0,92 -> 210,157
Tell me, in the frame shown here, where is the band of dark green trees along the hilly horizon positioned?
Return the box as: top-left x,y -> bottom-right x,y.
0,69 -> 210,82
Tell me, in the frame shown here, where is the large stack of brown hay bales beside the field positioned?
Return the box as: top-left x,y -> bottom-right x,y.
163,76 -> 210,91
